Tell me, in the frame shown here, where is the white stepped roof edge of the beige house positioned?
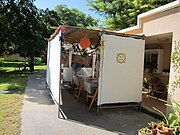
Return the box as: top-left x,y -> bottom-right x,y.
118,0 -> 180,33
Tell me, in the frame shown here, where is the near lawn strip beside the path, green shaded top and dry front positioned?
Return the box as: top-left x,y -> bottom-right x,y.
0,73 -> 28,135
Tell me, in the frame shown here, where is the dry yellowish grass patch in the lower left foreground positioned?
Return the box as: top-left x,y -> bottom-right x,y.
0,94 -> 23,135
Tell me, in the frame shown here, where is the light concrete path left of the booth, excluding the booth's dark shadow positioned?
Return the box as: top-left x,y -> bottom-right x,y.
21,71 -> 115,135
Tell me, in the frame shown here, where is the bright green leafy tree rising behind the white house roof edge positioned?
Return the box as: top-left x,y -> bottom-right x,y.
87,0 -> 174,29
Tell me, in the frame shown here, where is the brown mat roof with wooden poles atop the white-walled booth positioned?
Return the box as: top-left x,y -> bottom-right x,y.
48,26 -> 144,44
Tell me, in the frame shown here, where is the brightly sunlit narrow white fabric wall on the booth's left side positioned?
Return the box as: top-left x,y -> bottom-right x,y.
46,34 -> 62,104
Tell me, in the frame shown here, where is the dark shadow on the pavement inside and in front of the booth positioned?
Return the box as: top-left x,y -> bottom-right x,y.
61,86 -> 157,135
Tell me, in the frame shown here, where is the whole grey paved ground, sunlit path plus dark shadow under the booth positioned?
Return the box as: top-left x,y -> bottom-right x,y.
21,71 -> 156,135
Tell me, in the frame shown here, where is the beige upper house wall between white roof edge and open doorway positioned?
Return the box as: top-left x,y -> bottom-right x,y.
142,7 -> 180,36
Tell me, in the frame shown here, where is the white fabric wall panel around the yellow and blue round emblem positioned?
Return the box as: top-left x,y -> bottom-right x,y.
98,35 -> 145,105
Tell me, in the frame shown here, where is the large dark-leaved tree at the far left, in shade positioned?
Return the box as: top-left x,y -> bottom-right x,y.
0,0 -> 50,71
